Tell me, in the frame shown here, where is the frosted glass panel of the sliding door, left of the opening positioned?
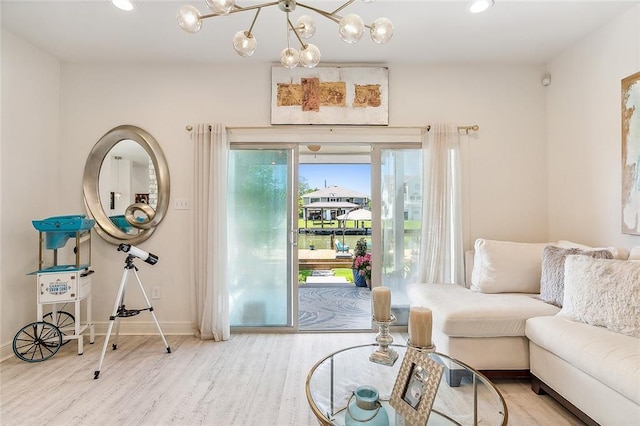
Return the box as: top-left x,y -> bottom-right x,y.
228,147 -> 297,327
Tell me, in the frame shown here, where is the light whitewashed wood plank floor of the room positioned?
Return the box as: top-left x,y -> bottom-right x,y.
0,333 -> 582,426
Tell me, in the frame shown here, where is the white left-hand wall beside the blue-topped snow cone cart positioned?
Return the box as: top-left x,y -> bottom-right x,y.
0,31 -> 61,355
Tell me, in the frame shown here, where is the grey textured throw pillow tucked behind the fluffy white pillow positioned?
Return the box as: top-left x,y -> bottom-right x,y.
540,246 -> 613,308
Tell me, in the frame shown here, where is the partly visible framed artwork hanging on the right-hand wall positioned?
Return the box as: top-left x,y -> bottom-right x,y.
622,72 -> 640,235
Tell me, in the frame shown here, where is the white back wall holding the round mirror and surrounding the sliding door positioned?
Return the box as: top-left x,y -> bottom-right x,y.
55,64 -> 547,338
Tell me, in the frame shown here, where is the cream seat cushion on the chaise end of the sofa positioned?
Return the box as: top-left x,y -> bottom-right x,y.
407,284 -> 560,337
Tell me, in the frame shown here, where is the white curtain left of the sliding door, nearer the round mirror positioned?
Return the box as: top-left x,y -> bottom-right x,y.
191,124 -> 230,340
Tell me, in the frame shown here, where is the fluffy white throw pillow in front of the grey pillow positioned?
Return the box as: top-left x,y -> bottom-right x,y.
558,256 -> 640,338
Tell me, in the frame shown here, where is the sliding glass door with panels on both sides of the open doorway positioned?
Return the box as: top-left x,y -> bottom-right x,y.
228,133 -> 423,330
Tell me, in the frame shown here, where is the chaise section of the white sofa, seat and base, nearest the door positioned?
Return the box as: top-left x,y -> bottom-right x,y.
409,284 -> 560,380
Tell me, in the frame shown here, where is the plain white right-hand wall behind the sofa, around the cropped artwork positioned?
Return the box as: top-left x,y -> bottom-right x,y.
547,6 -> 640,247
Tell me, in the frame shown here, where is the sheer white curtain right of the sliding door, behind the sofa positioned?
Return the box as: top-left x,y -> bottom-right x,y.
418,123 -> 464,284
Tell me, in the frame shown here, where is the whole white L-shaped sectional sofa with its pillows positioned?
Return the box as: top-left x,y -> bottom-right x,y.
408,239 -> 640,426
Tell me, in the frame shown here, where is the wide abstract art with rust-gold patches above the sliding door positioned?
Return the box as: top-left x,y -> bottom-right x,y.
271,67 -> 389,126
